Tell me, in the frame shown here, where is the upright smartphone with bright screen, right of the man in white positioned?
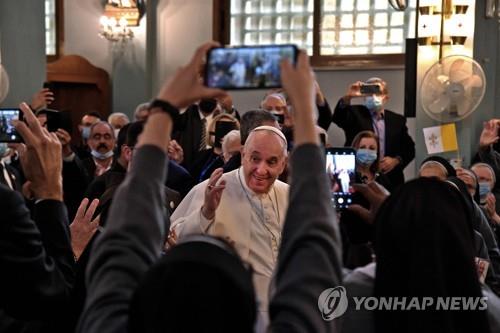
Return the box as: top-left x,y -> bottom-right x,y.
325,148 -> 356,210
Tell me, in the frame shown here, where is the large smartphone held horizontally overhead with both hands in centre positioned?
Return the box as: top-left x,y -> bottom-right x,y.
204,44 -> 298,90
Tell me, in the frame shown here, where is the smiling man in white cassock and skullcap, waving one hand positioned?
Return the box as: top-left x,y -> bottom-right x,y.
171,126 -> 288,320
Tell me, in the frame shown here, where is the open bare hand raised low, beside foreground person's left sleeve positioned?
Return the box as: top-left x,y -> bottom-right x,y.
69,198 -> 100,259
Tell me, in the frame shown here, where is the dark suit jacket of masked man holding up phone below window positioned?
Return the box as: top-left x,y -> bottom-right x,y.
332,100 -> 415,186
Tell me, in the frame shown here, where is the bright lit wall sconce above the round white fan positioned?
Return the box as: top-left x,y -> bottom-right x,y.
417,0 -> 473,59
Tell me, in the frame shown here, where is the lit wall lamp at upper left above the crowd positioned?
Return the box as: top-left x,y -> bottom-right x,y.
99,0 -> 145,43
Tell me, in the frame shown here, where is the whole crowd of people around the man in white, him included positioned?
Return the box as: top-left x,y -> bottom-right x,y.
0,43 -> 500,333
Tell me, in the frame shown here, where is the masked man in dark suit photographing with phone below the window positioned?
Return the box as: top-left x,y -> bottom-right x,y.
332,78 -> 415,186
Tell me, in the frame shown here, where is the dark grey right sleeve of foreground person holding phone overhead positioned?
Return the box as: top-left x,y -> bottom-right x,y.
269,144 -> 342,333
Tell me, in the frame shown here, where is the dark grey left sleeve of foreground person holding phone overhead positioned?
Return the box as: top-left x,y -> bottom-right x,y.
77,146 -> 170,332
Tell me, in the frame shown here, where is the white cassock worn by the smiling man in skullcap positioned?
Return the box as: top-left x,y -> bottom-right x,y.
170,168 -> 289,317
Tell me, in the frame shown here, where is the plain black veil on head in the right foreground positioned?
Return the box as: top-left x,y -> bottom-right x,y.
374,178 -> 489,333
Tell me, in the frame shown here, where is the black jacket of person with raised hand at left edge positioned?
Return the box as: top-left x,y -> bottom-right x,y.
0,185 -> 74,331
